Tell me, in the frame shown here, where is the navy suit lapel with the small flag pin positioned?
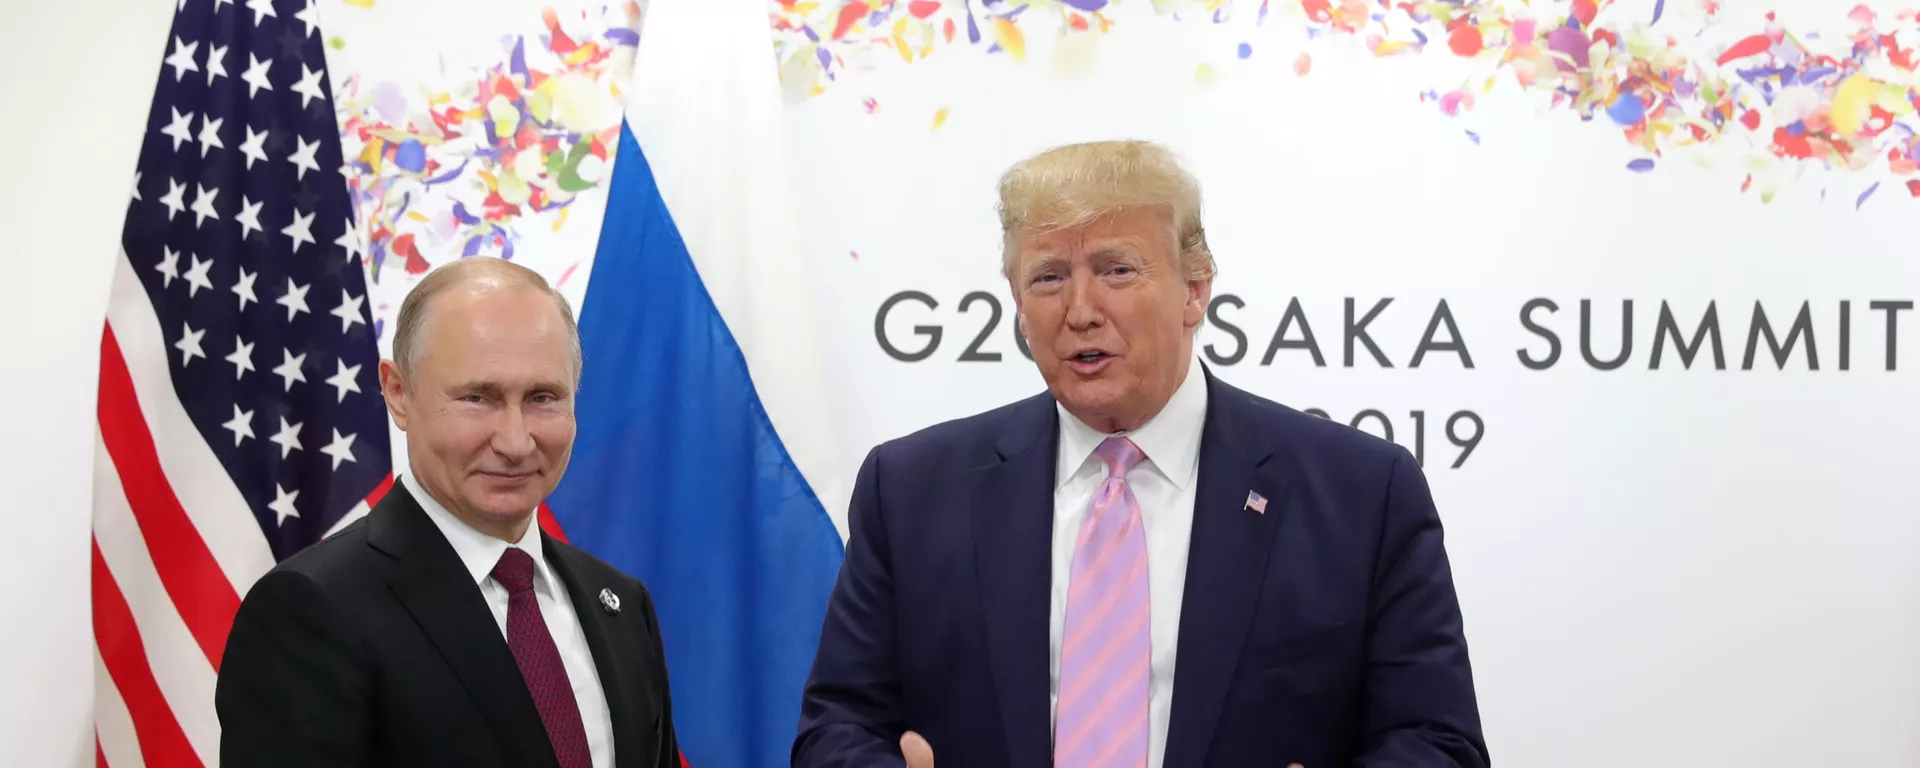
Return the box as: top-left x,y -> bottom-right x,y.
1165,372 -> 1286,768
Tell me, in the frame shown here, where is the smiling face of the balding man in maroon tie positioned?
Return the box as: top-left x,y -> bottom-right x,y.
380,280 -> 576,538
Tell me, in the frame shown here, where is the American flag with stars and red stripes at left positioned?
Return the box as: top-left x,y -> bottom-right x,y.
92,0 -> 392,768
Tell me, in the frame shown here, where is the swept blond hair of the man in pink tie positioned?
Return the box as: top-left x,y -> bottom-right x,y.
998,140 -> 1215,280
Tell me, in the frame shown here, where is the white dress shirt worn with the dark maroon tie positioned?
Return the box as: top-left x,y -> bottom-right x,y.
399,474 -> 612,768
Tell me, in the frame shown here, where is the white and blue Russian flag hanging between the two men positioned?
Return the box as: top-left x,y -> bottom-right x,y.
543,0 -> 845,768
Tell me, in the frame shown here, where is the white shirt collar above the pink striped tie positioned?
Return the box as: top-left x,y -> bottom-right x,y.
1054,357 -> 1208,490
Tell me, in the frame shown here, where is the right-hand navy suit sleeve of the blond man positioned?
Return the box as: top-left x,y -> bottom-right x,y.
1357,447 -> 1490,768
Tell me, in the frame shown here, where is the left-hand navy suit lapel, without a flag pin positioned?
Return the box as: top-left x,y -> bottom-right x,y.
972,396 -> 1060,768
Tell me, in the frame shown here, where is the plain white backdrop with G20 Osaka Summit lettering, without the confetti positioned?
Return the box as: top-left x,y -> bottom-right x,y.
11,0 -> 1920,768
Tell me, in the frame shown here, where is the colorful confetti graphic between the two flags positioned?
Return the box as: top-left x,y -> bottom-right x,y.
336,2 -> 639,280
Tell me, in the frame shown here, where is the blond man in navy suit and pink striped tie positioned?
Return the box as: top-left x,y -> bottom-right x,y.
793,142 -> 1488,768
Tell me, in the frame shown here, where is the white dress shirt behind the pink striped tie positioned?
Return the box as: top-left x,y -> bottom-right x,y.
1046,359 -> 1206,768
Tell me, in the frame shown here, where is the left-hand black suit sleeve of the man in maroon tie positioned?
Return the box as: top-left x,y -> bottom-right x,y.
213,572 -> 372,768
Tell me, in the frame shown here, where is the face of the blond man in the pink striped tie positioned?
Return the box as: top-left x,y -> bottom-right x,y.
1012,207 -> 1213,432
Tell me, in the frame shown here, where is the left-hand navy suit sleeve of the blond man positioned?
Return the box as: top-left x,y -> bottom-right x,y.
793,447 -> 904,768
